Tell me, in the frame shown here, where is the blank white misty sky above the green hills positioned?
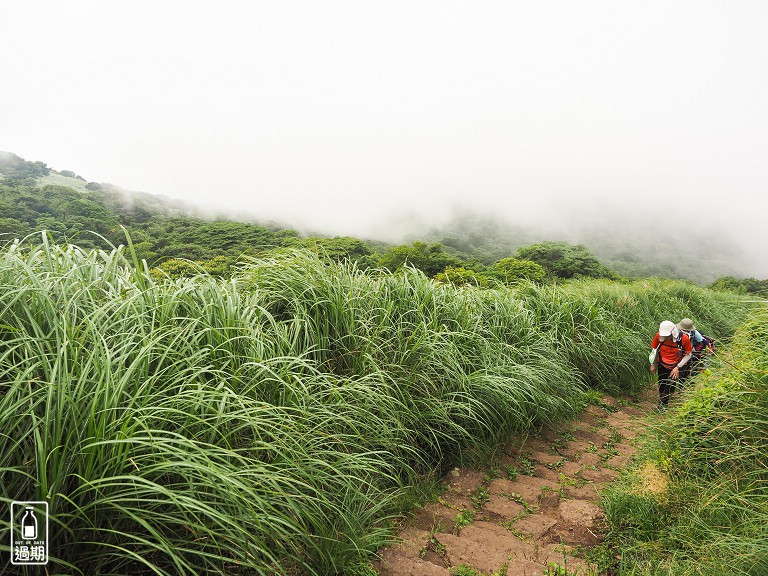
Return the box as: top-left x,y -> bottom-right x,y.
0,0 -> 768,277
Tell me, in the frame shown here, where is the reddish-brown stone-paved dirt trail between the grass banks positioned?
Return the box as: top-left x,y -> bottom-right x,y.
374,396 -> 655,576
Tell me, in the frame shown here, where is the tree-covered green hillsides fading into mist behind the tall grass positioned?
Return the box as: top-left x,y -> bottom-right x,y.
0,152 -> 765,292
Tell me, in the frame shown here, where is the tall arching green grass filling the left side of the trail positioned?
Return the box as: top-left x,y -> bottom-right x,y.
0,242 -> 752,575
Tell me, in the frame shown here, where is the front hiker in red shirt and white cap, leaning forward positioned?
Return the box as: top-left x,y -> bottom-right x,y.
651,320 -> 693,409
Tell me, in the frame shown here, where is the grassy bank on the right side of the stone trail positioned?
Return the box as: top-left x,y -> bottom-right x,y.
606,306 -> 768,576
